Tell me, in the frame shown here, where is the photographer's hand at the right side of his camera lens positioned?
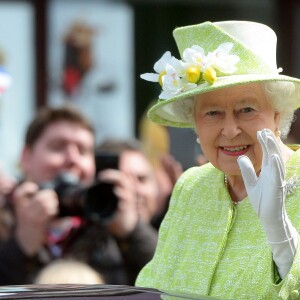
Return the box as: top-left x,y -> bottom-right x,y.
98,169 -> 138,238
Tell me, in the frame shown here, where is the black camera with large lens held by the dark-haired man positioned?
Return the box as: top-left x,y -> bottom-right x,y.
40,173 -> 118,223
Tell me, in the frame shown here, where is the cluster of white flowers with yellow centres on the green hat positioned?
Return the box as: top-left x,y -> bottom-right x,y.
141,43 -> 240,99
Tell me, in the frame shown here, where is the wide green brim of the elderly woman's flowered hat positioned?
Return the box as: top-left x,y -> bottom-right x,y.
148,74 -> 300,128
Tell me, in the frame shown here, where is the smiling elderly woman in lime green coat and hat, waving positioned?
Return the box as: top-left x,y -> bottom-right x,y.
136,21 -> 300,299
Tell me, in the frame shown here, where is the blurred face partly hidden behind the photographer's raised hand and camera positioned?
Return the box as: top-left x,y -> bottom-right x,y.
119,150 -> 159,222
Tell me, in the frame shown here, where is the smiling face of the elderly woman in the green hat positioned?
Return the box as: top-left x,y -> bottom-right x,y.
195,83 -> 279,175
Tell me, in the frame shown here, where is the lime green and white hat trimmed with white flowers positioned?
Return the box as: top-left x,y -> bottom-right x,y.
141,21 -> 300,127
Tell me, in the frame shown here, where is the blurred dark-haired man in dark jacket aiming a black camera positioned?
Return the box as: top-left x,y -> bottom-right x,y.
0,107 -> 157,285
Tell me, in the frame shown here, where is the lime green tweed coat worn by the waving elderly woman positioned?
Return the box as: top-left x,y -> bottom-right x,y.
136,150 -> 300,300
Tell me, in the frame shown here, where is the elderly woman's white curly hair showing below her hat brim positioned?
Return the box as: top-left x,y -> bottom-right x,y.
172,81 -> 299,138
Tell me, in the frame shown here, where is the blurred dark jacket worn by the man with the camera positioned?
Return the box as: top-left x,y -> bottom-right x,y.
0,206 -> 157,285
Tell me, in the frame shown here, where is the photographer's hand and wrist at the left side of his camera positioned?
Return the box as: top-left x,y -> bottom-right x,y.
13,182 -> 58,256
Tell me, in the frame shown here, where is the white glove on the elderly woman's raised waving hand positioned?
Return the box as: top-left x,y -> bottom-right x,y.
237,129 -> 298,278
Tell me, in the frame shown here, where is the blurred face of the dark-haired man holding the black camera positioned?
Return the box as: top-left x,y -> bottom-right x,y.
21,121 -> 95,184
